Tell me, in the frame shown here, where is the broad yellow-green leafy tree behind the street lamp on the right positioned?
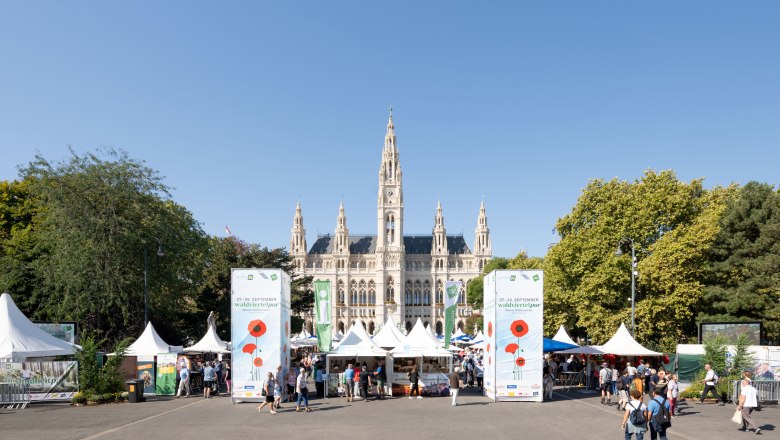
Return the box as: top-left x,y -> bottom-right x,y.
544,171 -> 728,348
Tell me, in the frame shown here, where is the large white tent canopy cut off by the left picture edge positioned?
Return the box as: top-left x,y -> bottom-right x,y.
0,293 -> 76,362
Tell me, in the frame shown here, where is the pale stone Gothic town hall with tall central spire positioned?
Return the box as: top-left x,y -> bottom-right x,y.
290,112 -> 492,334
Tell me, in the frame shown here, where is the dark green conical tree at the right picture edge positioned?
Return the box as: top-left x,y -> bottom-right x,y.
699,182 -> 780,343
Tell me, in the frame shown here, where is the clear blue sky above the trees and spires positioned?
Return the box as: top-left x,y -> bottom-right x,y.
0,1 -> 780,256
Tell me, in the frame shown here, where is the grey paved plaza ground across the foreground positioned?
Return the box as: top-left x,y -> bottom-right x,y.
0,390 -> 780,440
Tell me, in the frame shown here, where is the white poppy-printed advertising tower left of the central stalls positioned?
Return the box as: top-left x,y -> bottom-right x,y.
230,269 -> 290,401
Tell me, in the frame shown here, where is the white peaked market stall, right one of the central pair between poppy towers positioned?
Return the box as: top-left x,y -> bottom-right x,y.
387,318 -> 452,395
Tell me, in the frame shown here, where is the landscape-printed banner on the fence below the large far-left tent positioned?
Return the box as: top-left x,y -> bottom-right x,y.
0,361 -> 79,401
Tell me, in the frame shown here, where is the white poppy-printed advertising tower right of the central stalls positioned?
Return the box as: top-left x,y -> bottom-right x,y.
485,270 -> 544,402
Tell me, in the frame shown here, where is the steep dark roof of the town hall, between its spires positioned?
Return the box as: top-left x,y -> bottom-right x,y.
309,234 -> 471,255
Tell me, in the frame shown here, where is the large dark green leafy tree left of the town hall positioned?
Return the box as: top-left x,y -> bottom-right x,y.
22,149 -> 206,341
